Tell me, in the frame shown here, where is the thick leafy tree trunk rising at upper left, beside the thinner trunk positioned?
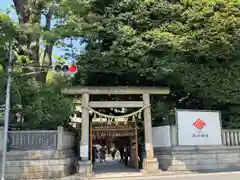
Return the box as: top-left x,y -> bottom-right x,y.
13,0 -> 46,77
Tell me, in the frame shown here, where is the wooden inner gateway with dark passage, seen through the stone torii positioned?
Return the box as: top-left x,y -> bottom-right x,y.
90,118 -> 139,177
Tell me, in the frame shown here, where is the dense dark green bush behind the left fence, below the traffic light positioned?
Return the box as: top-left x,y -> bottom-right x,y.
7,75 -> 73,129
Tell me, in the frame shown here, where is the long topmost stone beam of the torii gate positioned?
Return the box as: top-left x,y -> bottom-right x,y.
62,86 -> 170,95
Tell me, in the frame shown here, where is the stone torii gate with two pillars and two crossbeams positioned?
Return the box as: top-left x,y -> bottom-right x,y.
62,86 -> 170,175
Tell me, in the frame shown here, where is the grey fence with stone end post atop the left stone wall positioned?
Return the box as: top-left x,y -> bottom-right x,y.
0,127 -> 75,151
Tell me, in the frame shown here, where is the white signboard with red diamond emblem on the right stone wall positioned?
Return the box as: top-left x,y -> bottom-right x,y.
176,110 -> 222,146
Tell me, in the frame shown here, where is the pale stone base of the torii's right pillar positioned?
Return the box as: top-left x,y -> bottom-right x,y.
141,158 -> 161,173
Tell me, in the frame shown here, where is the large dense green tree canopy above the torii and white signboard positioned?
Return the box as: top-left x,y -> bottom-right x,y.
62,0 -> 240,127
